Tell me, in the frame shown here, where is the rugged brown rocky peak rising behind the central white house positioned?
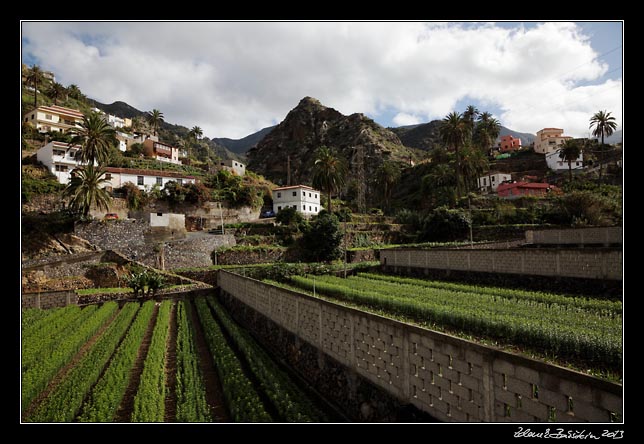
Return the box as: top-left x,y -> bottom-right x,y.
247,97 -> 417,185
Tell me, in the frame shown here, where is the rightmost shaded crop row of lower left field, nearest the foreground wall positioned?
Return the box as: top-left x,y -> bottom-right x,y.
207,296 -> 325,422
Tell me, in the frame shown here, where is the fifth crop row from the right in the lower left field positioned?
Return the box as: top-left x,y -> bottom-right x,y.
79,301 -> 154,422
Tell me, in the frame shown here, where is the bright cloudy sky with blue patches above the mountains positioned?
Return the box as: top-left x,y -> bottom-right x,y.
22,22 -> 623,138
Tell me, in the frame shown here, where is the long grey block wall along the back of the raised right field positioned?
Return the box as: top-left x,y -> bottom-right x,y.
380,248 -> 622,280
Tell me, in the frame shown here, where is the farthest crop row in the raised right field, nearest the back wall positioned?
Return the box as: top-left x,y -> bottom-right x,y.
358,273 -> 622,315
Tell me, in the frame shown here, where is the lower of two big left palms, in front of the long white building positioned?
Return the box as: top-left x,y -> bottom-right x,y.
63,164 -> 111,217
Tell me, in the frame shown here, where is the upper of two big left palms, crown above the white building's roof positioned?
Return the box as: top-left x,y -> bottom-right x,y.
69,112 -> 116,165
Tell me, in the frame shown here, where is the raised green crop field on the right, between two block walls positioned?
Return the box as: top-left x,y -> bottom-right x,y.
291,273 -> 622,373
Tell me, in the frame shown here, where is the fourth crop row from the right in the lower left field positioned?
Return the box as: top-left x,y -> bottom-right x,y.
132,300 -> 173,422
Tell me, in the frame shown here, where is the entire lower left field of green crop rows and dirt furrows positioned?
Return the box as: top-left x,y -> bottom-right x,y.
21,296 -> 328,422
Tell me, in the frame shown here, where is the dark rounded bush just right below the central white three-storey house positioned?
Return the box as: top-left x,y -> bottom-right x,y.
302,211 -> 343,262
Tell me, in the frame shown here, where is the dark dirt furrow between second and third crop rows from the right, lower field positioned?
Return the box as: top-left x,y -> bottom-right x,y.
186,300 -> 231,422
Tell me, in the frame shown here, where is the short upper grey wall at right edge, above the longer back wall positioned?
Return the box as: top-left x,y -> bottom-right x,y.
525,227 -> 623,246
